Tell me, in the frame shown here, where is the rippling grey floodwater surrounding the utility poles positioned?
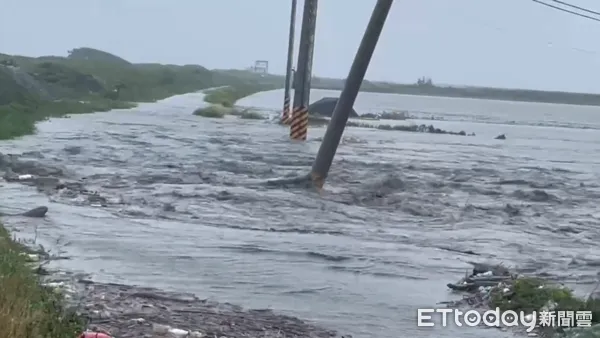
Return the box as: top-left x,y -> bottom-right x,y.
0,91 -> 600,338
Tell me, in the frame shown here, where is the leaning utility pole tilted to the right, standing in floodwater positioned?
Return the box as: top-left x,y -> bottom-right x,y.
310,0 -> 394,190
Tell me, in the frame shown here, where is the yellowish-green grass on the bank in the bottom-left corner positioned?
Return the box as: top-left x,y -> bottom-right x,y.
0,224 -> 84,338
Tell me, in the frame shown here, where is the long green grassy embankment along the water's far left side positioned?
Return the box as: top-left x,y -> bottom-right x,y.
0,48 -> 276,140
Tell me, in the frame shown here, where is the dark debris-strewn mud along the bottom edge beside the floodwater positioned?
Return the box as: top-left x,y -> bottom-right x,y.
73,281 -> 336,338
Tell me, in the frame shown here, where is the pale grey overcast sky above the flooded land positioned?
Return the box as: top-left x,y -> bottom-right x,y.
0,0 -> 600,92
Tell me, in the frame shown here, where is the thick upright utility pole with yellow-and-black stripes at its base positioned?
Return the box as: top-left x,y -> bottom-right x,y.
290,0 -> 318,141
